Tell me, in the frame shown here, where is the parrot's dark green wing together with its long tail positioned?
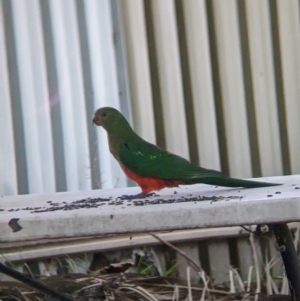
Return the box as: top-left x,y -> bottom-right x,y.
119,137 -> 280,188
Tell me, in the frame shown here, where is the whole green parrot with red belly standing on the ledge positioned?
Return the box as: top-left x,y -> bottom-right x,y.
93,107 -> 280,197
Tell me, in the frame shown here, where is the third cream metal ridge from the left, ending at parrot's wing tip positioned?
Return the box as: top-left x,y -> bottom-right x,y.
183,0 -> 221,170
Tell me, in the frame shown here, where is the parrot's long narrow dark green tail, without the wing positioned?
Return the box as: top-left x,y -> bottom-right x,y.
199,177 -> 282,188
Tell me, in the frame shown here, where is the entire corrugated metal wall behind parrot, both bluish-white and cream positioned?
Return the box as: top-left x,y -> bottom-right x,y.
0,0 -> 300,195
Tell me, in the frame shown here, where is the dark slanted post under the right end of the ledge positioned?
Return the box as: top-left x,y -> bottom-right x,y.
273,224 -> 300,301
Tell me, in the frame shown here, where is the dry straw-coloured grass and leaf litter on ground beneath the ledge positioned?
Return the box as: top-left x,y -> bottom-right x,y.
0,225 -> 299,301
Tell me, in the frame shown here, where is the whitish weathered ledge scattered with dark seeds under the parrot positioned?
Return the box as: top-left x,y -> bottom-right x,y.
0,175 -> 300,242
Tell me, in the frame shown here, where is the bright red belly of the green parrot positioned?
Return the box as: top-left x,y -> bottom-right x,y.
121,164 -> 184,194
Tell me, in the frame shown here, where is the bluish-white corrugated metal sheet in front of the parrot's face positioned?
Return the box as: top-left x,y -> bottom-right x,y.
0,0 -> 128,194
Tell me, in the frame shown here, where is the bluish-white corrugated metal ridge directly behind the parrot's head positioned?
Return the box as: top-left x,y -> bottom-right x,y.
84,0 -> 127,188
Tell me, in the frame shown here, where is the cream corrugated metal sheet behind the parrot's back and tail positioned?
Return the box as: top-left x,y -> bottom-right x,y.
122,0 -> 300,177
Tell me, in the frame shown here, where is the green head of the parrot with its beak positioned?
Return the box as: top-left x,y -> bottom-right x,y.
93,107 -> 130,133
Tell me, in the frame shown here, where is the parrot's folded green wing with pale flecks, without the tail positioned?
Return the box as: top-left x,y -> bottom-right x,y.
119,139 -> 222,181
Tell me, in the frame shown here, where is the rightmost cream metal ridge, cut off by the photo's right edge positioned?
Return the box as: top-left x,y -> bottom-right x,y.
277,0 -> 300,174
